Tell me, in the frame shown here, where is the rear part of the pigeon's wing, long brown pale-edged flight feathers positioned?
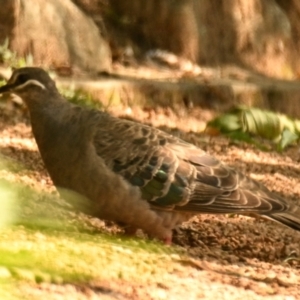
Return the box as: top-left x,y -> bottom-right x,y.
170,143 -> 289,214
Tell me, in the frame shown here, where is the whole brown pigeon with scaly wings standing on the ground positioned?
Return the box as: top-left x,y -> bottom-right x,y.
0,67 -> 300,244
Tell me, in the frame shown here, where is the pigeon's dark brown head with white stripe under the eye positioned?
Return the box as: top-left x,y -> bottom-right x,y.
0,67 -> 56,100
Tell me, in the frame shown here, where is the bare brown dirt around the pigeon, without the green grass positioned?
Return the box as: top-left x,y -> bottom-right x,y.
0,78 -> 300,299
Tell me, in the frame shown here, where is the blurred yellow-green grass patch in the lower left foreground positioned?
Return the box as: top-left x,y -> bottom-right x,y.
0,178 -> 179,295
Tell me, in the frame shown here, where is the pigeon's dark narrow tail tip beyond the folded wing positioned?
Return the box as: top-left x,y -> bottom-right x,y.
265,205 -> 300,231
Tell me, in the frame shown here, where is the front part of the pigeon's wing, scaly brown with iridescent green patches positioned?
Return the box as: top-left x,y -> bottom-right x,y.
94,117 -> 194,208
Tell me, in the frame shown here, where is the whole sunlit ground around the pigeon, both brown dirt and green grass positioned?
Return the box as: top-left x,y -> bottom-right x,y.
0,69 -> 300,299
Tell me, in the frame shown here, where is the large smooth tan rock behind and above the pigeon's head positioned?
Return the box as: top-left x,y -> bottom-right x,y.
0,0 -> 111,72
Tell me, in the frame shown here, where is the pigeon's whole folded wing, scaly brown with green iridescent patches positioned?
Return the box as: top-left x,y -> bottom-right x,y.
94,113 -> 287,213
